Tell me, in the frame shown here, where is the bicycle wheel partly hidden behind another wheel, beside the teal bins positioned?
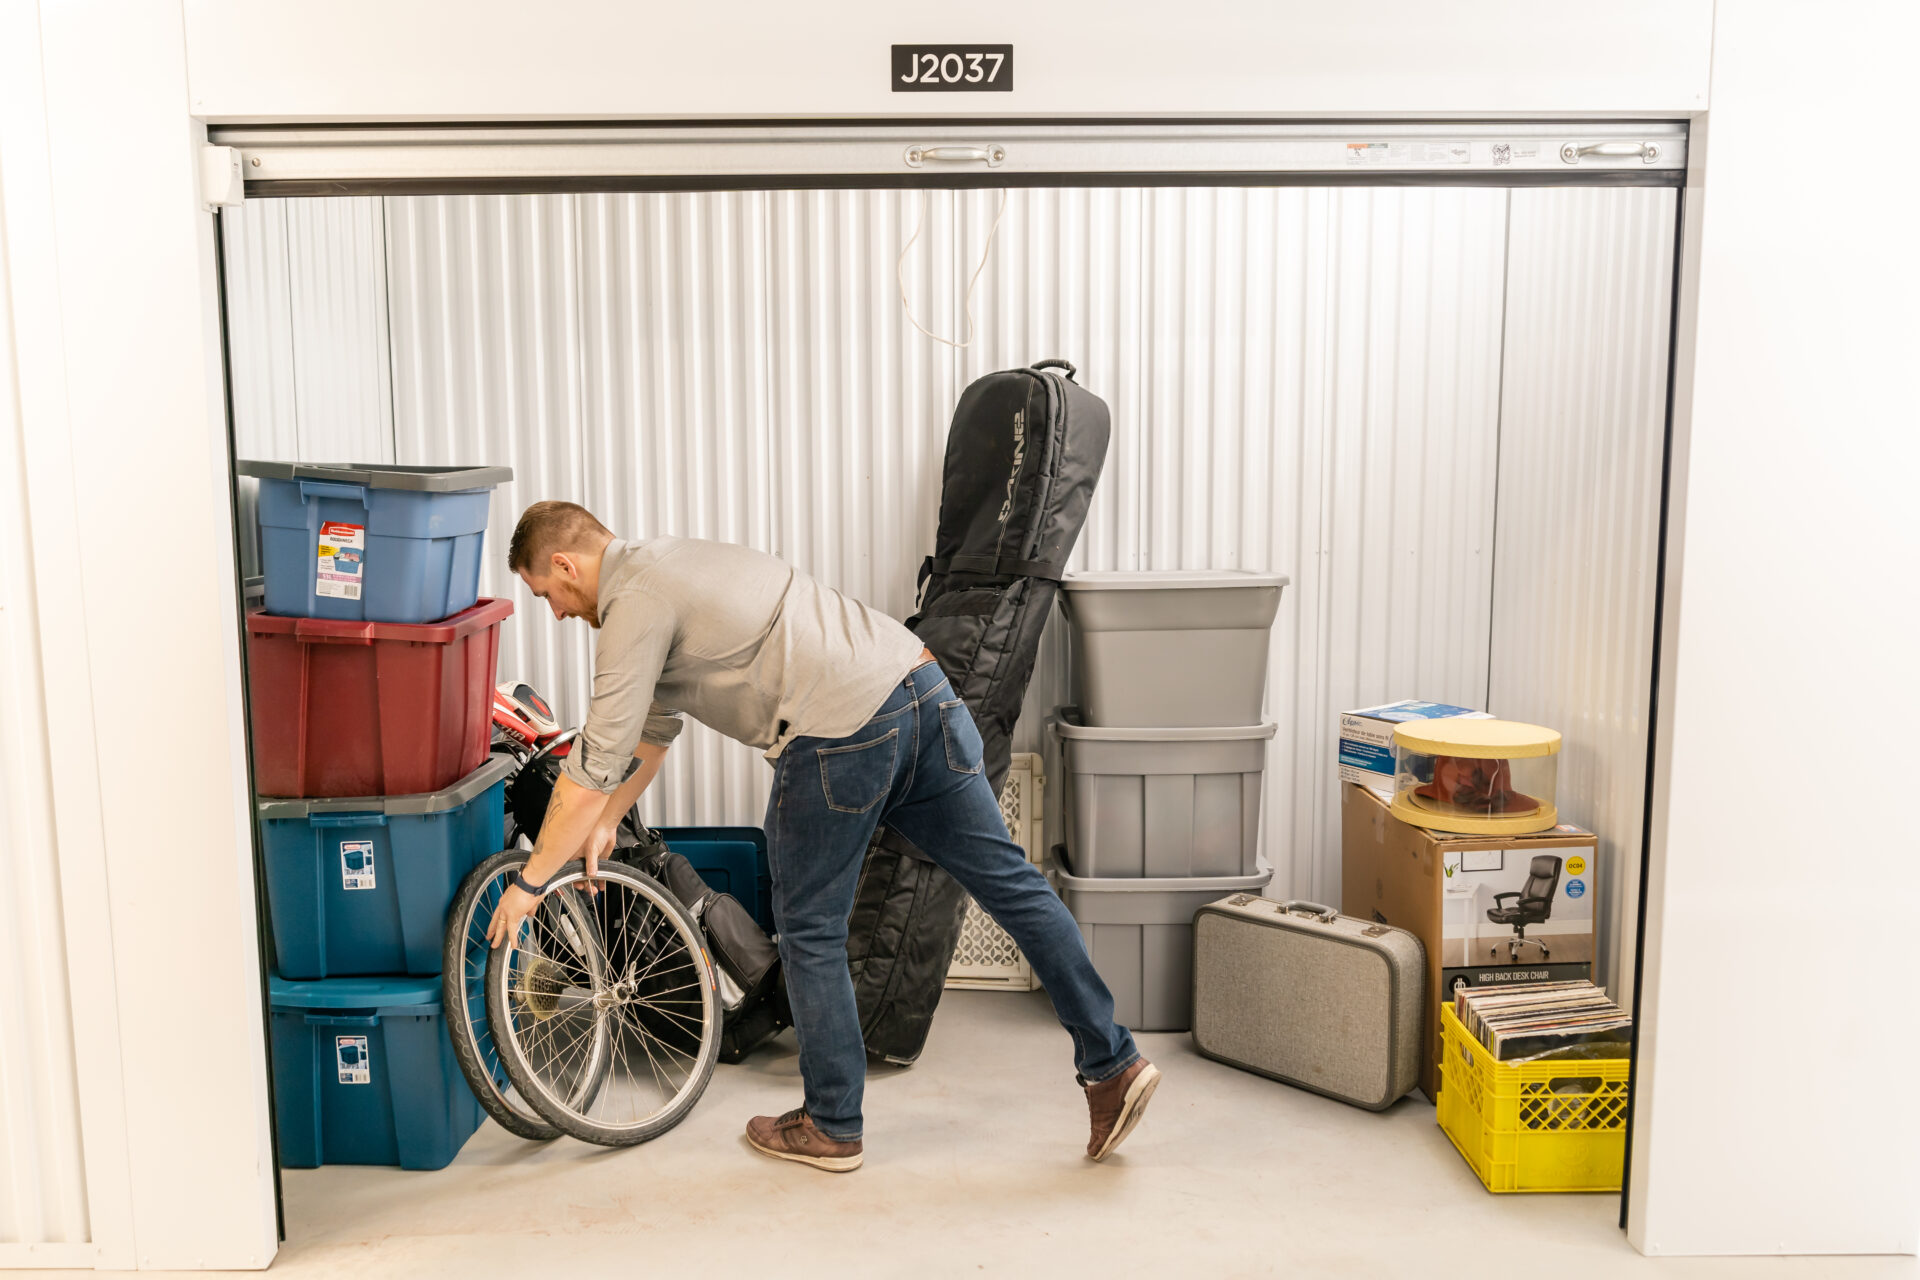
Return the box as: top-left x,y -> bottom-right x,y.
440,848 -> 607,1142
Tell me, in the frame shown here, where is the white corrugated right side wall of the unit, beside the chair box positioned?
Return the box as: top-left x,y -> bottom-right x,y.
1490,190 -> 1676,998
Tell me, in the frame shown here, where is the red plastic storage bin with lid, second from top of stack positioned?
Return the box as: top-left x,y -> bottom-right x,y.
246,601 -> 513,798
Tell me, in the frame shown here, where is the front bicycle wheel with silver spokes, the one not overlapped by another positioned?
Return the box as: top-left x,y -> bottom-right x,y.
486,862 -> 724,1148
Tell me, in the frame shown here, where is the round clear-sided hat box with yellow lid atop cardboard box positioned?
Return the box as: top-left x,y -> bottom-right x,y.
1392,716 -> 1559,835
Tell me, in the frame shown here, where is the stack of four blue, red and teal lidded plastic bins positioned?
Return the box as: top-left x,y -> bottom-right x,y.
238,462 -> 513,1169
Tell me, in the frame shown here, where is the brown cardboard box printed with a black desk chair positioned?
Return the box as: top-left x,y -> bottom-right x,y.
1340,785 -> 1597,1100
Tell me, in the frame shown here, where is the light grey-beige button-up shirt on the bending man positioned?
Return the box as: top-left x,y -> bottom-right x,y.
563,537 -> 922,793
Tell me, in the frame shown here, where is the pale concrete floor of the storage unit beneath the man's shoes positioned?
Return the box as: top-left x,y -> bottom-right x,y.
60,992 -> 1920,1280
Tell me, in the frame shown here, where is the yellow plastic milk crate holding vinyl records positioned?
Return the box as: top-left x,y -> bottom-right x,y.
1434,1002 -> 1628,1192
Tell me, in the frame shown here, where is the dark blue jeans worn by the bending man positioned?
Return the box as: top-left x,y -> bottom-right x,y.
766,662 -> 1140,1142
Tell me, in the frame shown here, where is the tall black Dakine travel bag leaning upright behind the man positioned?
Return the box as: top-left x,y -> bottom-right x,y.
847,361 -> 1110,1063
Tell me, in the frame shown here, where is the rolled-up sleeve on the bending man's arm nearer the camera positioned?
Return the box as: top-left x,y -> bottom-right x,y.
561,593 -> 682,794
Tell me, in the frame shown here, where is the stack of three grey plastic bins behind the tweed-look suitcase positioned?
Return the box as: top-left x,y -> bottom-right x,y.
1052,570 -> 1286,1031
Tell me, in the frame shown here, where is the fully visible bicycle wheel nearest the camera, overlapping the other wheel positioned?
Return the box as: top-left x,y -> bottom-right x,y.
486,862 -> 720,1146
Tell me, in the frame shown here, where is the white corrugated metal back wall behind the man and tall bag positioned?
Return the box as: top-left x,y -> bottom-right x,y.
217,188 -> 1670,936
